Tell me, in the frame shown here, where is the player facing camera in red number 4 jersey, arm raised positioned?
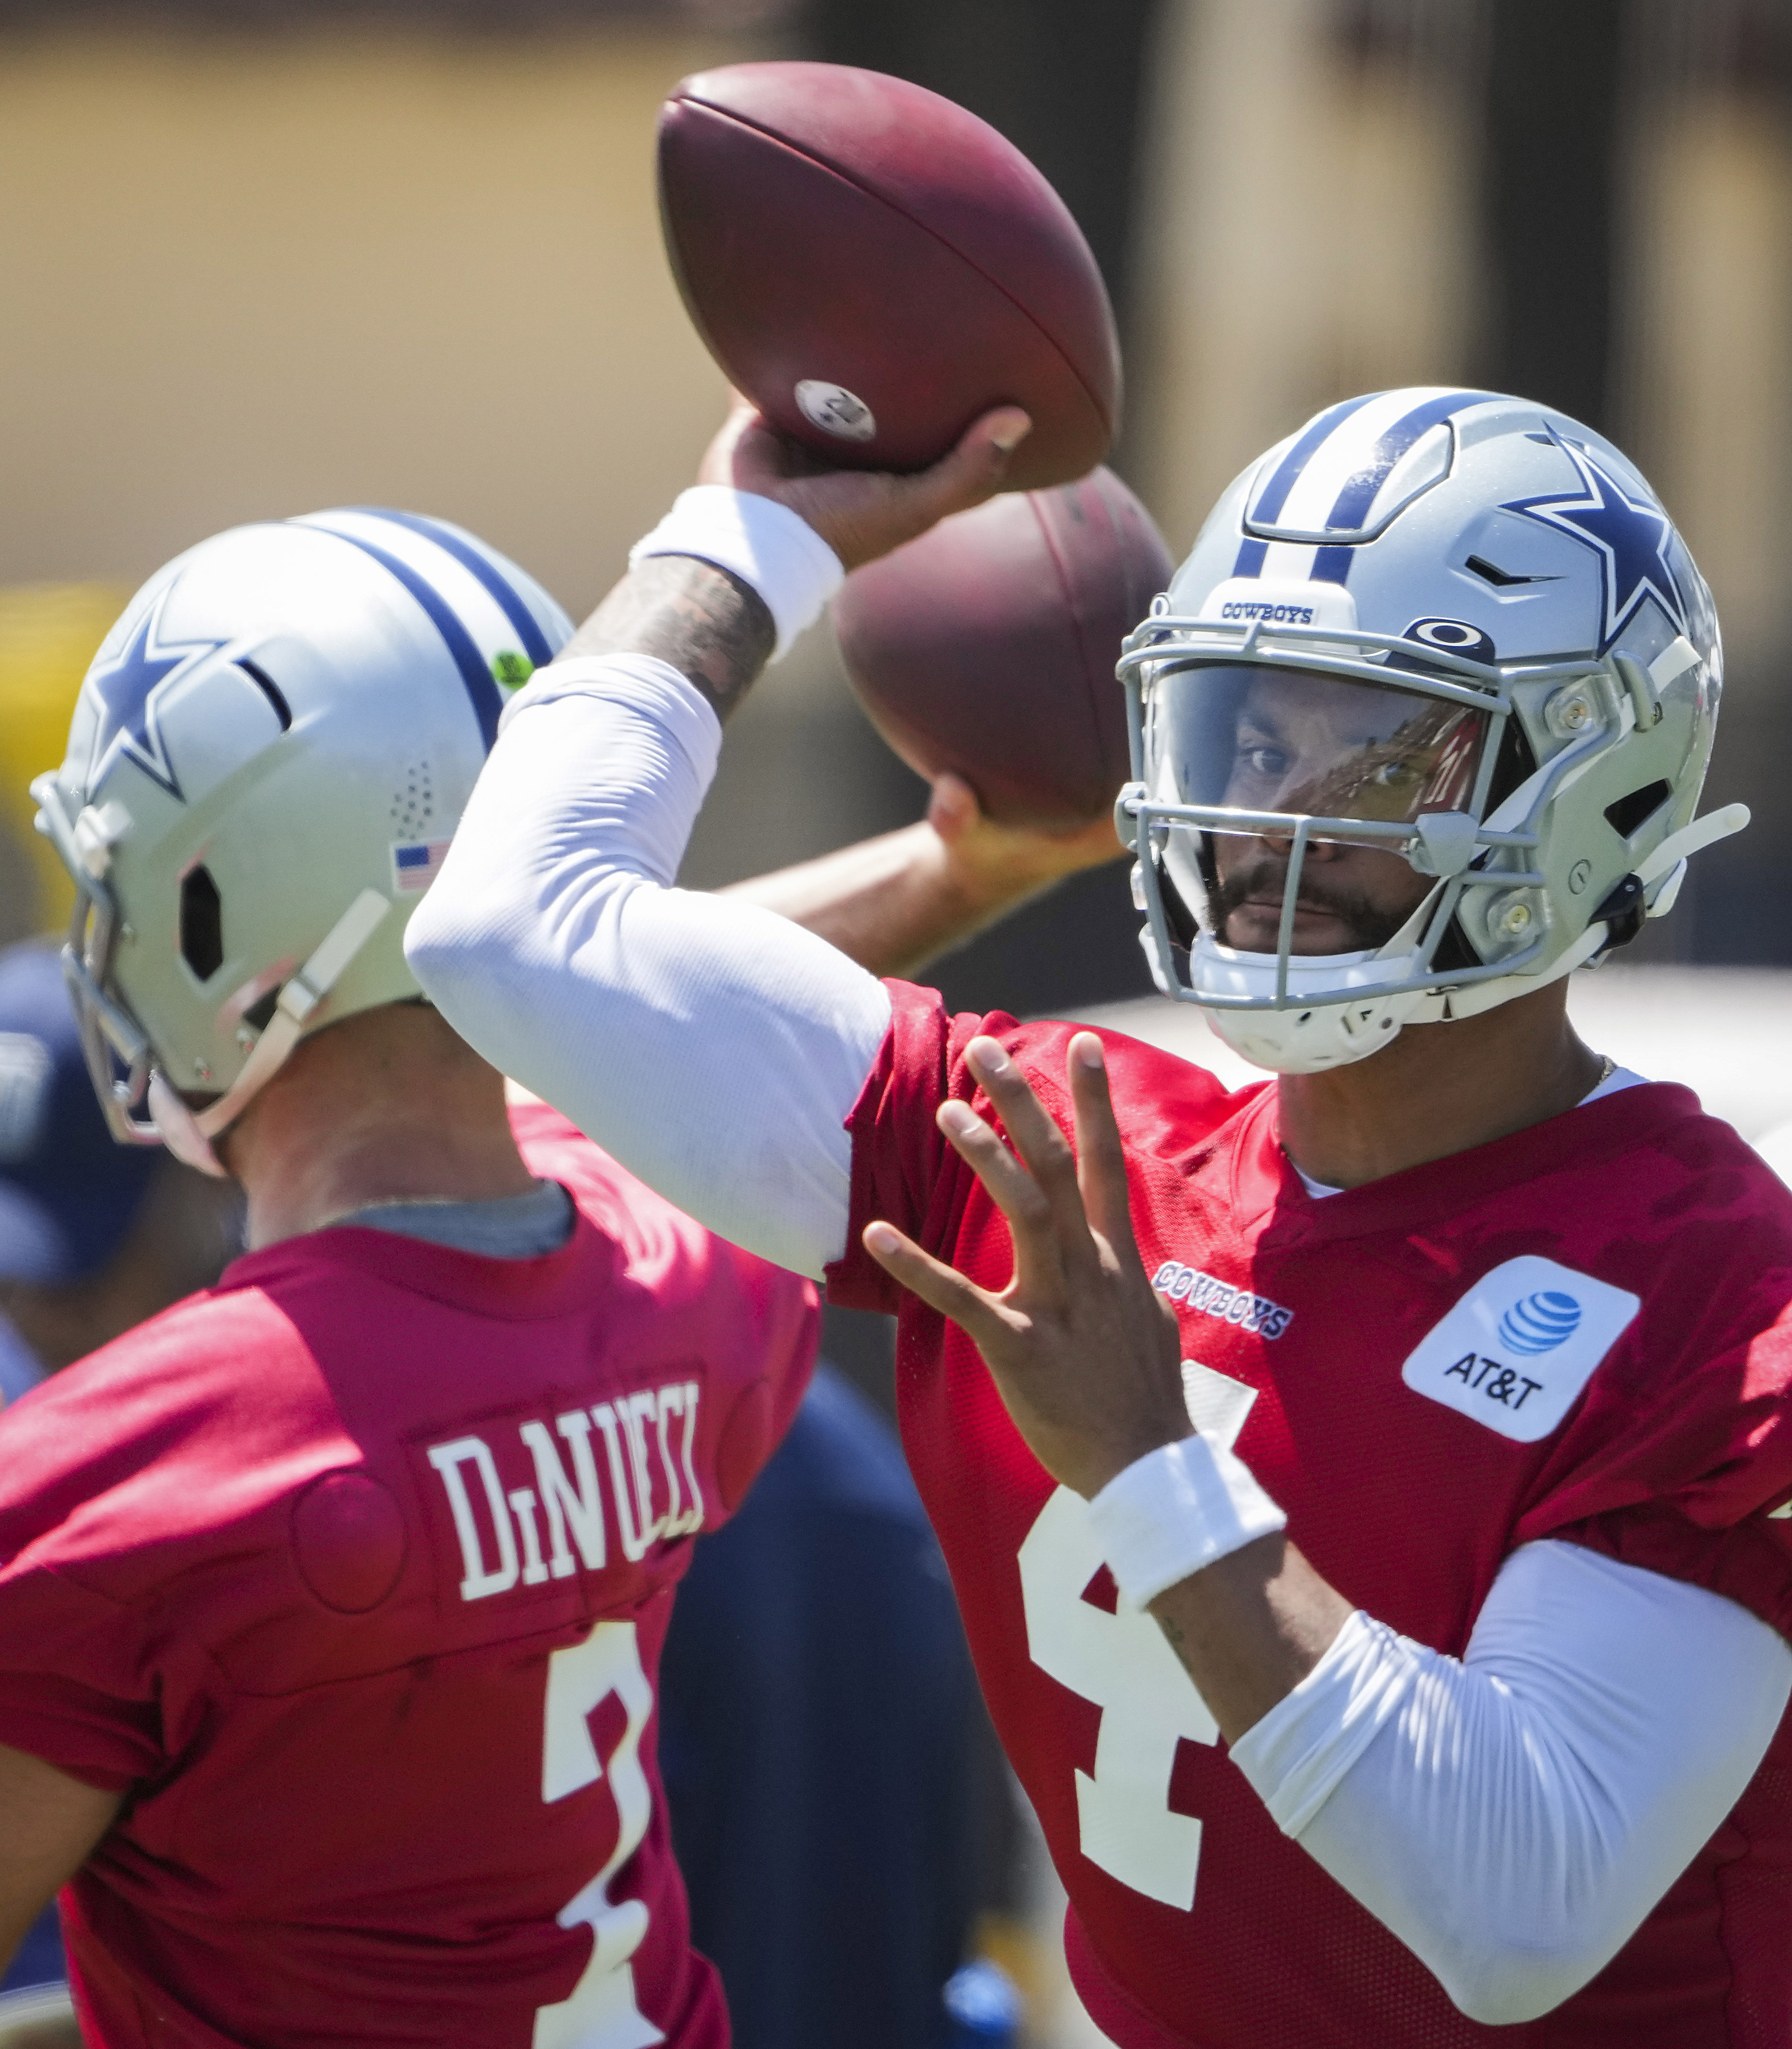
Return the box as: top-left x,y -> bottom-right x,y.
412,389 -> 1792,2049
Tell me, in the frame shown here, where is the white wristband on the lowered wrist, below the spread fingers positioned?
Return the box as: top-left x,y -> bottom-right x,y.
1090,1436 -> 1288,1610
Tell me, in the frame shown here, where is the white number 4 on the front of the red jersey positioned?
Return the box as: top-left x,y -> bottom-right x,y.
1020,1361 -> 1255,1912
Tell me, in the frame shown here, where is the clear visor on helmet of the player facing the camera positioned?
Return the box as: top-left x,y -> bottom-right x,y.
1147,662 -> 1489,844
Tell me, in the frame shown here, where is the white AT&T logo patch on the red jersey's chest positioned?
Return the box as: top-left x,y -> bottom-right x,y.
1401,1254 -> 1640,1445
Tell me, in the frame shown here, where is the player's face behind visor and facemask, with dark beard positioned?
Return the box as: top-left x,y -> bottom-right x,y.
1153,664 -> 1487,955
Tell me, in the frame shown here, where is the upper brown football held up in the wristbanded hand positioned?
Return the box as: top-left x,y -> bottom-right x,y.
659,64 -> 1120,490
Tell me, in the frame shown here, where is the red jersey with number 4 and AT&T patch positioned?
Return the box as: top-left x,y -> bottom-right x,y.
829,983 -> 1792,2049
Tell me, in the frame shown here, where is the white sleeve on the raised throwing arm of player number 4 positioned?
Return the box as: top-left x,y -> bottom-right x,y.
406,656 -> 891,1277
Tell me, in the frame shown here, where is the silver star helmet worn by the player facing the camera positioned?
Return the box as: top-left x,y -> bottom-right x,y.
1118,389 -> 1749,1074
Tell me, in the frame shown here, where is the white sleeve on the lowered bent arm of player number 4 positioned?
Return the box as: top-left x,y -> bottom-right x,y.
1231,1543 -> 1792,2024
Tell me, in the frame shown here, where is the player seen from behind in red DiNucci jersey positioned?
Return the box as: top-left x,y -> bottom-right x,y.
0,492 -> 1112,2049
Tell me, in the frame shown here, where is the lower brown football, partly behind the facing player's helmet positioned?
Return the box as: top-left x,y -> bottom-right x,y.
833,469 -> 1174,826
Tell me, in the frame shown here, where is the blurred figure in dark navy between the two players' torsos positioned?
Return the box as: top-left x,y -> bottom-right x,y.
659,1361 -> 993,2049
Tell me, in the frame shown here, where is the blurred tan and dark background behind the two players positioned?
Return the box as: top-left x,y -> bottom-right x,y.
0,0 -> 1792,2041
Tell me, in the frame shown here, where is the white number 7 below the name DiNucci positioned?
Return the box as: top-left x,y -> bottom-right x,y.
534,1623 -> 665,2049
